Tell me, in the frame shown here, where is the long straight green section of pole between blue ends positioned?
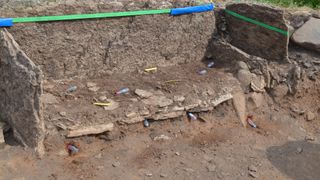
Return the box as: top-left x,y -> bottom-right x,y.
12,9 -> 171,23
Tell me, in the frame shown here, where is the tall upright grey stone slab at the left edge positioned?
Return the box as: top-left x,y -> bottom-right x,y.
0,30 -> 44,155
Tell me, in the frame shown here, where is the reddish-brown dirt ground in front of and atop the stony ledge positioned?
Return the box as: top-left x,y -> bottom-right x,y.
0,50 -> 320,180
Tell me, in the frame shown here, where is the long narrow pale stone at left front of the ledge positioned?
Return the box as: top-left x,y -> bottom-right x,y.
67,123 -> 114,137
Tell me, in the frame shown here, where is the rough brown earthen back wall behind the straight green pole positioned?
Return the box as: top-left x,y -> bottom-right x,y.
2,0 -> 215,79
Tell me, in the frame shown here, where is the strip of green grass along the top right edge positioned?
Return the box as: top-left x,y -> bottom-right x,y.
256,0 -> 320,9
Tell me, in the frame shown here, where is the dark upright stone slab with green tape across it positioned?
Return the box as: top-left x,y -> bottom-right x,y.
226,3 -> 289,61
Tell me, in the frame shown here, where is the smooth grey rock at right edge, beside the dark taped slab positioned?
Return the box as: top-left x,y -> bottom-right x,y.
292,18 -> 320,52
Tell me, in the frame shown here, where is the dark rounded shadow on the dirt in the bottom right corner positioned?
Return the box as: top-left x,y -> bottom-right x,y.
267,141 -> 320,180
